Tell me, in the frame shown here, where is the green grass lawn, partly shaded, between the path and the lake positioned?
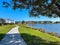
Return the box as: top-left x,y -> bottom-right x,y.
19,25 -> 60,45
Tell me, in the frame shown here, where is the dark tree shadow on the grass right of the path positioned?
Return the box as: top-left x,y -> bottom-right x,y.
21,33 -> 60,45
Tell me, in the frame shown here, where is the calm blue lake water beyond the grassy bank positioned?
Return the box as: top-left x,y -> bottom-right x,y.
29,24 -> 60,34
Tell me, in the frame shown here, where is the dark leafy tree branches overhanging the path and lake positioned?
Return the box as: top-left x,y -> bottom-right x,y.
3,0 -> 60,17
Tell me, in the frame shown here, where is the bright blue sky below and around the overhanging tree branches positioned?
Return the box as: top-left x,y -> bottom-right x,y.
0,0 -> 60,21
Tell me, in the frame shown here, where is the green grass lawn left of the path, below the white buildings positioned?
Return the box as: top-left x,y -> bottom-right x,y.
0,25 -> 15,40
